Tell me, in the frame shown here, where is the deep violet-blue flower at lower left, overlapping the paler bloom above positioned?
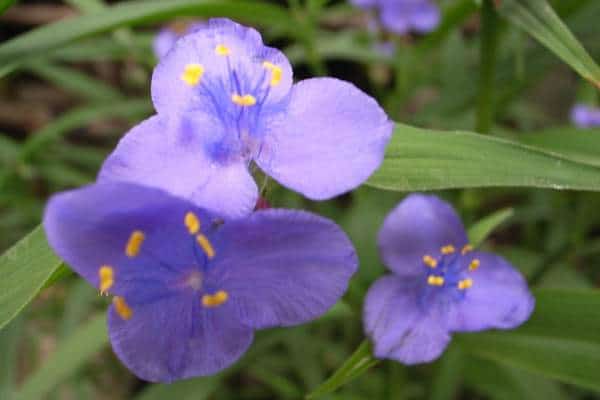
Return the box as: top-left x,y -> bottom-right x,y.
44,183 -> 357,382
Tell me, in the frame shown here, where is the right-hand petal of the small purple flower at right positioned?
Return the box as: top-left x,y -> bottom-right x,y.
449,252 -> 535,331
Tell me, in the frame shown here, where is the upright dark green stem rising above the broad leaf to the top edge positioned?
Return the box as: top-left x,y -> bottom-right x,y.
475,0 -> 499,133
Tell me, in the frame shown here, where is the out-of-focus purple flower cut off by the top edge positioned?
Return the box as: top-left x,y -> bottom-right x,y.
351,0 -> 440,35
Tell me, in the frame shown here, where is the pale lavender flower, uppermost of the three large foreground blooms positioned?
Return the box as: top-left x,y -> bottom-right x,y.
100,19 -> 393,217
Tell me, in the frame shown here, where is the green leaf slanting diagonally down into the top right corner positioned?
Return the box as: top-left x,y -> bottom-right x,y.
496,0 -> 600,88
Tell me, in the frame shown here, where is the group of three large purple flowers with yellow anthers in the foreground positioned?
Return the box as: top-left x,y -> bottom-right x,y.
44,19 -> 533,382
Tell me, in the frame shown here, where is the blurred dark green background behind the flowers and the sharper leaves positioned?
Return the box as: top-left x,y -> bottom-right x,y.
0,0 -> 600,400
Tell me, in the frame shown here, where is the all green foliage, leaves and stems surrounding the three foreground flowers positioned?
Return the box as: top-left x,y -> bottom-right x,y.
0,0 -> 600,400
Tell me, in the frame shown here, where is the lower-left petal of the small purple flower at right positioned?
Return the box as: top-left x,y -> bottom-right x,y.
363,275 -> 450,364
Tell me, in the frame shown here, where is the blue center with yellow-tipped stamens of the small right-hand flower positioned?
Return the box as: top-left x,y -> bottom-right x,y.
419,245 -> 480,308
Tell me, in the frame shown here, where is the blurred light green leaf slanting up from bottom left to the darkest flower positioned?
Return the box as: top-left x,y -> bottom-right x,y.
14,313 -> 108,400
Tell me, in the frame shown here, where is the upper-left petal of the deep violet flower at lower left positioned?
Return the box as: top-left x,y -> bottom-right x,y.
44,183 -> 214,301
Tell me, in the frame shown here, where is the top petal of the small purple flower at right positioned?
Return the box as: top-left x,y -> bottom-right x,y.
378,194 -> 467,276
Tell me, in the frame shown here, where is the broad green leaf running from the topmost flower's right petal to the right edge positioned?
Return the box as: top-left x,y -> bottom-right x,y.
367,124 -> 600,192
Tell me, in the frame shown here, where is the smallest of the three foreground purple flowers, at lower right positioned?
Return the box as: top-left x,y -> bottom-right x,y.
364,194 -> 534,364
